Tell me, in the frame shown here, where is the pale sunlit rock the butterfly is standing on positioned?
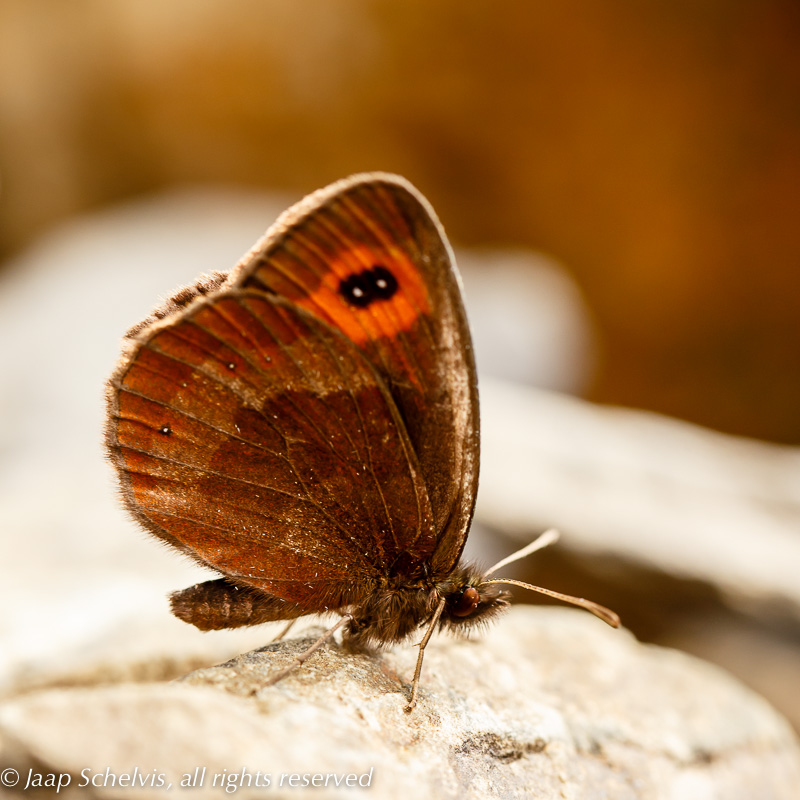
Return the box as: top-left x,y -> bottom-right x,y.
0,607 -> 800,800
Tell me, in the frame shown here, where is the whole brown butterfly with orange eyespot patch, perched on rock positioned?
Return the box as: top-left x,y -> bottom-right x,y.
107,173 -> 618,710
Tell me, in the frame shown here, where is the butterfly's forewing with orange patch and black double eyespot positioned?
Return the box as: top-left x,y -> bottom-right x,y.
231,174 -> 478,575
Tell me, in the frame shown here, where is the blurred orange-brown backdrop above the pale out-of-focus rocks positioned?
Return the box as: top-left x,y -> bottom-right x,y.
0,0 -> 800,443
